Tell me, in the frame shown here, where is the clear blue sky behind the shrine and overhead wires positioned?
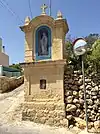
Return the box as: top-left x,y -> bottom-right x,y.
0,0 -> 100,64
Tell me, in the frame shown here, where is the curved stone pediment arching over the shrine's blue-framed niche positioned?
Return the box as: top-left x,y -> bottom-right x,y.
20,15 -> 69,33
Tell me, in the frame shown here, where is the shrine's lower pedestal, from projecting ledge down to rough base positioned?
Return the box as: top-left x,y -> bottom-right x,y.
22,60 -> 68,126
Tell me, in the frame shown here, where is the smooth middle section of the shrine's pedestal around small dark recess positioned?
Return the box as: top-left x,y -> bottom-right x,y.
24,62 -> 64,103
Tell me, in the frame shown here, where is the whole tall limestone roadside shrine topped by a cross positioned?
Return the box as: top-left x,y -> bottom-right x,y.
20,5 -> 69,126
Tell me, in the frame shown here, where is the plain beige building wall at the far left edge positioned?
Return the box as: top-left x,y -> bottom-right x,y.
0,53 -> 9,66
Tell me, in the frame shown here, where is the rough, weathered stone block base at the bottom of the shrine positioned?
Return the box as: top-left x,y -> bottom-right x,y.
22,101 -> 68,127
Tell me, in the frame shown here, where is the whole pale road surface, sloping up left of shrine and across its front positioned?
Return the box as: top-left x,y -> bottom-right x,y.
0,85 -> 79,134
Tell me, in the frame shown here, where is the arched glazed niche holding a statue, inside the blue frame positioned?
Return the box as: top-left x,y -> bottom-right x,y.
36,26 -> 51,60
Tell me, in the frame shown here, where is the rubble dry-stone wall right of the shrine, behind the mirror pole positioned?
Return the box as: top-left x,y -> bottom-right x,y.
64,70 -> 100,127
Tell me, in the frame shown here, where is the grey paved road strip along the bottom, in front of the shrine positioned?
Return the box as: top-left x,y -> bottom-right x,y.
0,125 -> 74,134
